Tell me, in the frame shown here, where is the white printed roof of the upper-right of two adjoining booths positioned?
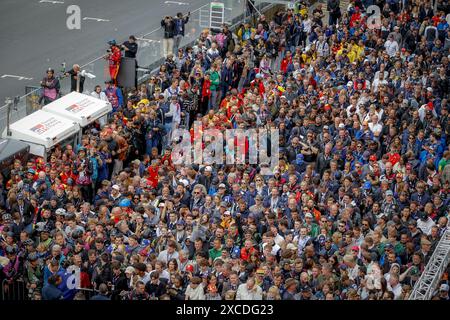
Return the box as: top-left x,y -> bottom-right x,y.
42,92 -> 112,128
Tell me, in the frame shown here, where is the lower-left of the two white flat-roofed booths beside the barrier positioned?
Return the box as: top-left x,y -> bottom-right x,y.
2,110 -> 81,158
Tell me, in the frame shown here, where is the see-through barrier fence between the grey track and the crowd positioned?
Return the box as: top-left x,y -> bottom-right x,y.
0,0 -> 274,133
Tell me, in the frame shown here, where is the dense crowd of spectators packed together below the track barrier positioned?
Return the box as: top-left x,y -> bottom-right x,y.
0,0 -> 450,300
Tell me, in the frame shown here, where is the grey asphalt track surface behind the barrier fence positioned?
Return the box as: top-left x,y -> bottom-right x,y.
0,0 -> 210,117
